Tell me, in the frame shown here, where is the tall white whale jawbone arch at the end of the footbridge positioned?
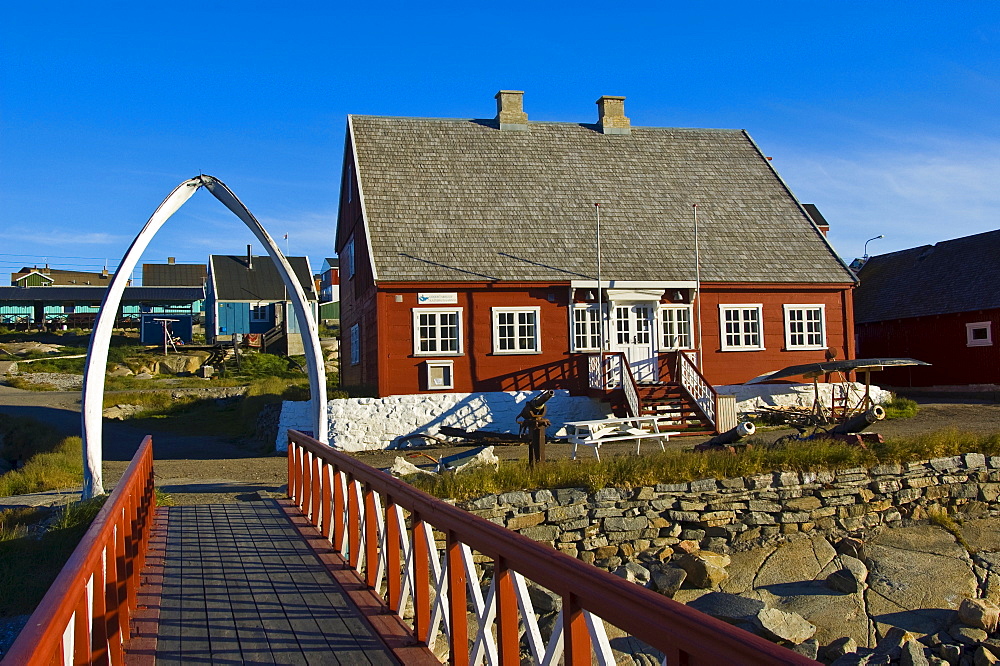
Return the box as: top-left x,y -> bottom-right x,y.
81,175 -> 328,499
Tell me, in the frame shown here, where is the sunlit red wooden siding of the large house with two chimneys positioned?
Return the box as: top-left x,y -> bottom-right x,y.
356,280 -> 854,395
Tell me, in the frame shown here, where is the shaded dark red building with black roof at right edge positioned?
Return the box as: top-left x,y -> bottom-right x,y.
854,230 -> 1000,386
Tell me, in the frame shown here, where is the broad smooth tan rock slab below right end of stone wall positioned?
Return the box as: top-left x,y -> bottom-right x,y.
864,525 -> 977,634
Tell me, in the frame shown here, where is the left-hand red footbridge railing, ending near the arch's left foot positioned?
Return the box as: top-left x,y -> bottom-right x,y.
3,436 -> 156,665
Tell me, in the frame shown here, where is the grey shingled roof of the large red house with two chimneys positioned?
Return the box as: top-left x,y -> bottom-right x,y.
351,116 -> 854,283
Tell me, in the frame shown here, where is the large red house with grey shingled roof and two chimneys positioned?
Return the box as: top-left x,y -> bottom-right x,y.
336,91 -> 855,420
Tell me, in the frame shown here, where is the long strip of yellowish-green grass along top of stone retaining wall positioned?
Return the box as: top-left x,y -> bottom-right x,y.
406,430 -> 1000,501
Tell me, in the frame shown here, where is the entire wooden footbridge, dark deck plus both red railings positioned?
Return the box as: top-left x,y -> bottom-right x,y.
3,432 -> 816,666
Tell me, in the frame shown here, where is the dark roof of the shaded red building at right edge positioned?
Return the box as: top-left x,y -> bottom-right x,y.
854,230 -> 1000,324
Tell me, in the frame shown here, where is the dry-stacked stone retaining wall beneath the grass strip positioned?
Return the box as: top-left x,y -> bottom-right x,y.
460,453 -> 1000,569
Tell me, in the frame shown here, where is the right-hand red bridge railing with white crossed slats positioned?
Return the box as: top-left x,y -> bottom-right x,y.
288,431 -> 816,666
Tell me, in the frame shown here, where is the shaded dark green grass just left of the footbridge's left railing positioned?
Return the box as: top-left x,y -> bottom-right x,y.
0,496 -> 107,617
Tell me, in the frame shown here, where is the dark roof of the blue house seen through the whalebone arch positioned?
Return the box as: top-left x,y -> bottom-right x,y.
209,254 -> 316,301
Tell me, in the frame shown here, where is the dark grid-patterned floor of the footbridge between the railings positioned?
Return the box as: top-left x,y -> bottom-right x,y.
148,499 -> 397,664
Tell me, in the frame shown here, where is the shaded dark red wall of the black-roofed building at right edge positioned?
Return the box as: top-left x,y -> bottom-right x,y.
857,310 -> 1000,386
